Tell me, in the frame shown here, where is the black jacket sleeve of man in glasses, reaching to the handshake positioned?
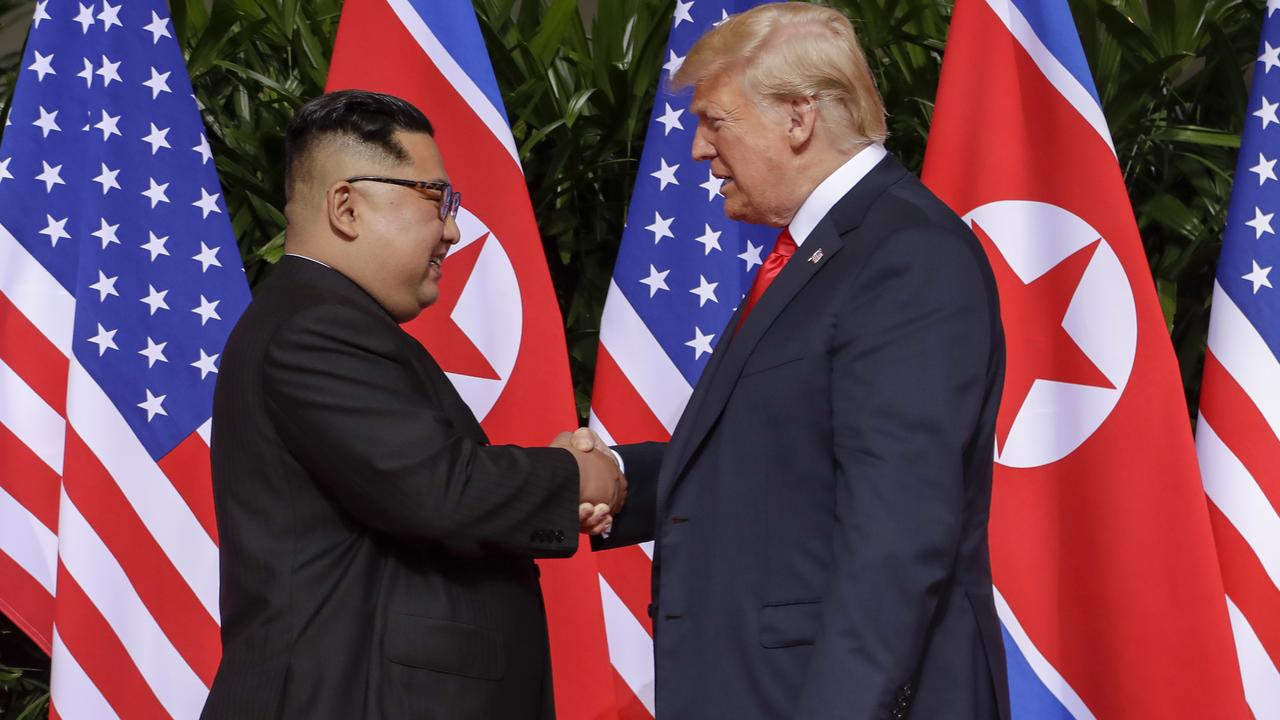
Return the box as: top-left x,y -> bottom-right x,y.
262,301 -> 579,557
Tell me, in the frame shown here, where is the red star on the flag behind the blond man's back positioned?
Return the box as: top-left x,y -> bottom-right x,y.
973,223 -> 1115,450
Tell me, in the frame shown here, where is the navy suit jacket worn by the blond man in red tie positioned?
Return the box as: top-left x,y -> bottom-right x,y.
598,158 -> 1009,720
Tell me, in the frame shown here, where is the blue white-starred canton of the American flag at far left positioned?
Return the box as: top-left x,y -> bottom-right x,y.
0,0 -> 250,459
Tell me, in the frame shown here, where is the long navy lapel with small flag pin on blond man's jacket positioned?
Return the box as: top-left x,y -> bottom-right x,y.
659,155 -> 906,497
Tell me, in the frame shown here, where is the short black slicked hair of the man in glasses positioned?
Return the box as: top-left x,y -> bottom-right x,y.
284,90 -> 435,196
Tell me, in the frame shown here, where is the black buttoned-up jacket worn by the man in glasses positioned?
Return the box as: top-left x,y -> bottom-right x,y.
202,256 -> 579,720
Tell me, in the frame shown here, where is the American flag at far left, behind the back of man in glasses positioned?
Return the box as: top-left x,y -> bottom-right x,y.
0,0 -> 250,720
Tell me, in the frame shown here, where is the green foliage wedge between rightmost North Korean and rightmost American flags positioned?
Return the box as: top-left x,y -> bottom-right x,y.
1071,0 -> 1265,409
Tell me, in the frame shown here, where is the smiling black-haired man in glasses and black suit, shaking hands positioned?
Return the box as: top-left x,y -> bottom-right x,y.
202,91 -> 625,720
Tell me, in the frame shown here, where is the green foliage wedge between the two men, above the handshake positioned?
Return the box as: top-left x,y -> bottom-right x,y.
475,0 -> 673,416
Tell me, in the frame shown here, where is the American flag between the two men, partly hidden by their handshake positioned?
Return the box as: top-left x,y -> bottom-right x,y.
590,0 -> 778,719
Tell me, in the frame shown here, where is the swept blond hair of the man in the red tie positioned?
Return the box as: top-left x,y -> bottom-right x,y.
672,3 -> 888,142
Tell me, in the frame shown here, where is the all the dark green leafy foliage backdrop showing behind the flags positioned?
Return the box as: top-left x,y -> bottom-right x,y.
0,0 -> 1265,720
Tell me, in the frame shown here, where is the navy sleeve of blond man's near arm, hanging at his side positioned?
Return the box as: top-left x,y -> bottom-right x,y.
796,229 -> 998,720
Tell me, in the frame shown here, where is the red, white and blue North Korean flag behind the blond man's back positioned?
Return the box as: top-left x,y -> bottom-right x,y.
924,0 -> 1251,720
